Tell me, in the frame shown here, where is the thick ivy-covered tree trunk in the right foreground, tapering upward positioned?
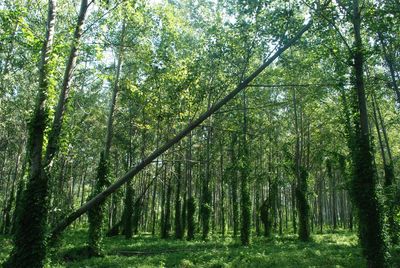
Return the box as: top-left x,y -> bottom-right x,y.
352,0 -> 386,267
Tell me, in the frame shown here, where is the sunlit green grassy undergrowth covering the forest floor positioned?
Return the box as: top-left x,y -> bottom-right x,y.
0,229 -> 400,267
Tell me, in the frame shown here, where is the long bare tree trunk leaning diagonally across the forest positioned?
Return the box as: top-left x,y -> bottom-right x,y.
49,20 -> 313,240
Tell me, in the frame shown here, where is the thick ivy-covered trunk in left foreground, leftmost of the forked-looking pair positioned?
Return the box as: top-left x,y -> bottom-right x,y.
4,0 -> 57,267
